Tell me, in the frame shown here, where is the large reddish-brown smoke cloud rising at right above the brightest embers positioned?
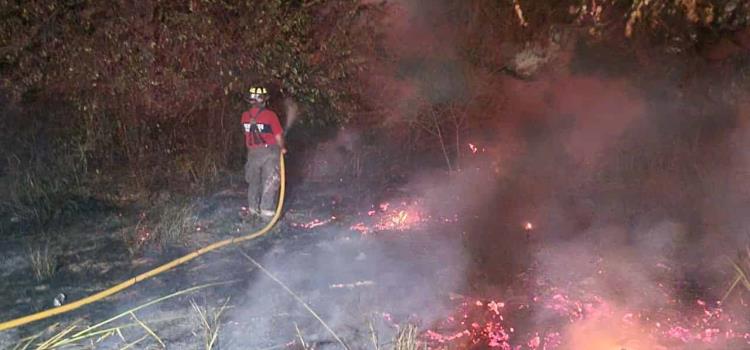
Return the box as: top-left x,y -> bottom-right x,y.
484,56 -> 748,349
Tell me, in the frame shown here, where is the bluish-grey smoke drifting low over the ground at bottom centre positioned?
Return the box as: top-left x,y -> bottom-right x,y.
225,129 -> 496,349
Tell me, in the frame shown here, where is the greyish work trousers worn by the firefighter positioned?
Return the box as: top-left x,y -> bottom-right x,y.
245,146 -> 279,212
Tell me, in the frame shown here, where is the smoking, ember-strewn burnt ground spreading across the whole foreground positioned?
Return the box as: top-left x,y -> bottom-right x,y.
6,123 -> 750,349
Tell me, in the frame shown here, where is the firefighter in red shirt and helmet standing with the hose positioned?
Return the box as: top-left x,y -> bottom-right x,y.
242,87 -> 286,218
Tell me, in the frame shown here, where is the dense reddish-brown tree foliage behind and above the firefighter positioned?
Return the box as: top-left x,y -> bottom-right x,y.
0,0 -> 379,186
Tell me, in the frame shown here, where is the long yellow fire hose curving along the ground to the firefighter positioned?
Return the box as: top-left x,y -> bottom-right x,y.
0,154 -> 286,331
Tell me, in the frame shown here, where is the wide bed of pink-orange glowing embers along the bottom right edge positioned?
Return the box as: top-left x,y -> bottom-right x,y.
422,288 -> 750,350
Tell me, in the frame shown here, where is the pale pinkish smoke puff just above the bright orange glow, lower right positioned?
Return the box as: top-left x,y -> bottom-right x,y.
536,222 -> 685,310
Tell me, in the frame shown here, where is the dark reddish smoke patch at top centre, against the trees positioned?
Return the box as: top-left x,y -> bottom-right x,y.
365,0 -> 469,125
